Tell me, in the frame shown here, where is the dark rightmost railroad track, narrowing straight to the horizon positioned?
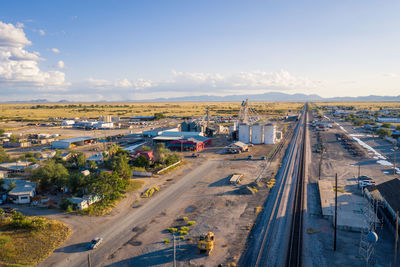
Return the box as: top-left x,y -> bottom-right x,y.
286,108 -> 308,267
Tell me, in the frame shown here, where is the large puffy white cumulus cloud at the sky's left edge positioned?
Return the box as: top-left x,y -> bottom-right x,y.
0,21 -> 65,89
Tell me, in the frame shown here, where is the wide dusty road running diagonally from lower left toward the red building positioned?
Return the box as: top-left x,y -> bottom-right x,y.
40,160 -> 220,266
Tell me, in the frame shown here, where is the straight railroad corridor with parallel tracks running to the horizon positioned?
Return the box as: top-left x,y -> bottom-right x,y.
239,107 -> 307,266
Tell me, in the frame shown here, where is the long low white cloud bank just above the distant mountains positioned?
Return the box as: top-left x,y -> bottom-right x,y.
79,70 -> 314,99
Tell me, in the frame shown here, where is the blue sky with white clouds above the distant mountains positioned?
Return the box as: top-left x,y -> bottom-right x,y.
0,0 -> 400,101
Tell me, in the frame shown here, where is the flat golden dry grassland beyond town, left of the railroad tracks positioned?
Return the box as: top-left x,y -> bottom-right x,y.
0,102 -> 304,121
